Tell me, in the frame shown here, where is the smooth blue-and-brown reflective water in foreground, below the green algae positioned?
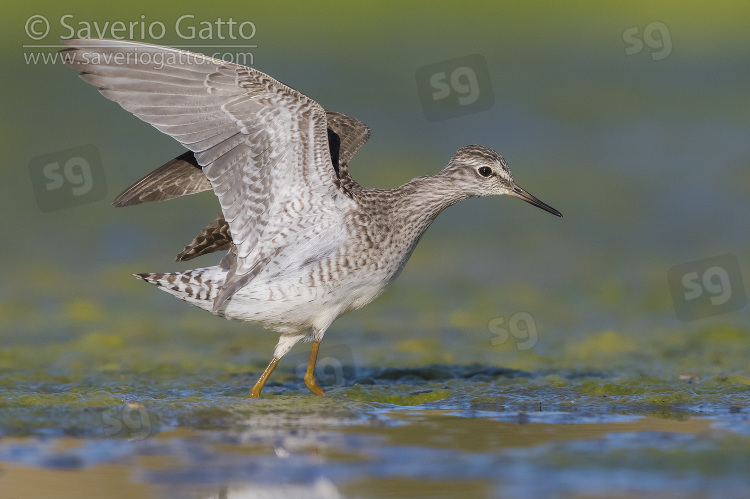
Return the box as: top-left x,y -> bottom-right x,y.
0,407 -> 750,499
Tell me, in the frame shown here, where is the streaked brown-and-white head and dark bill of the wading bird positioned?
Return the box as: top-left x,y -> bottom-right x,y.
440,145 -> 562,217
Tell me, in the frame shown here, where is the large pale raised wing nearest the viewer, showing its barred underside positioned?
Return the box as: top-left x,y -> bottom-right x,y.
65,40 -> 356,311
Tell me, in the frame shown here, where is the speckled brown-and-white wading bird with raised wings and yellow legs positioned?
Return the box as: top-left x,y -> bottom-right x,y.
63,39 -> 562,398
